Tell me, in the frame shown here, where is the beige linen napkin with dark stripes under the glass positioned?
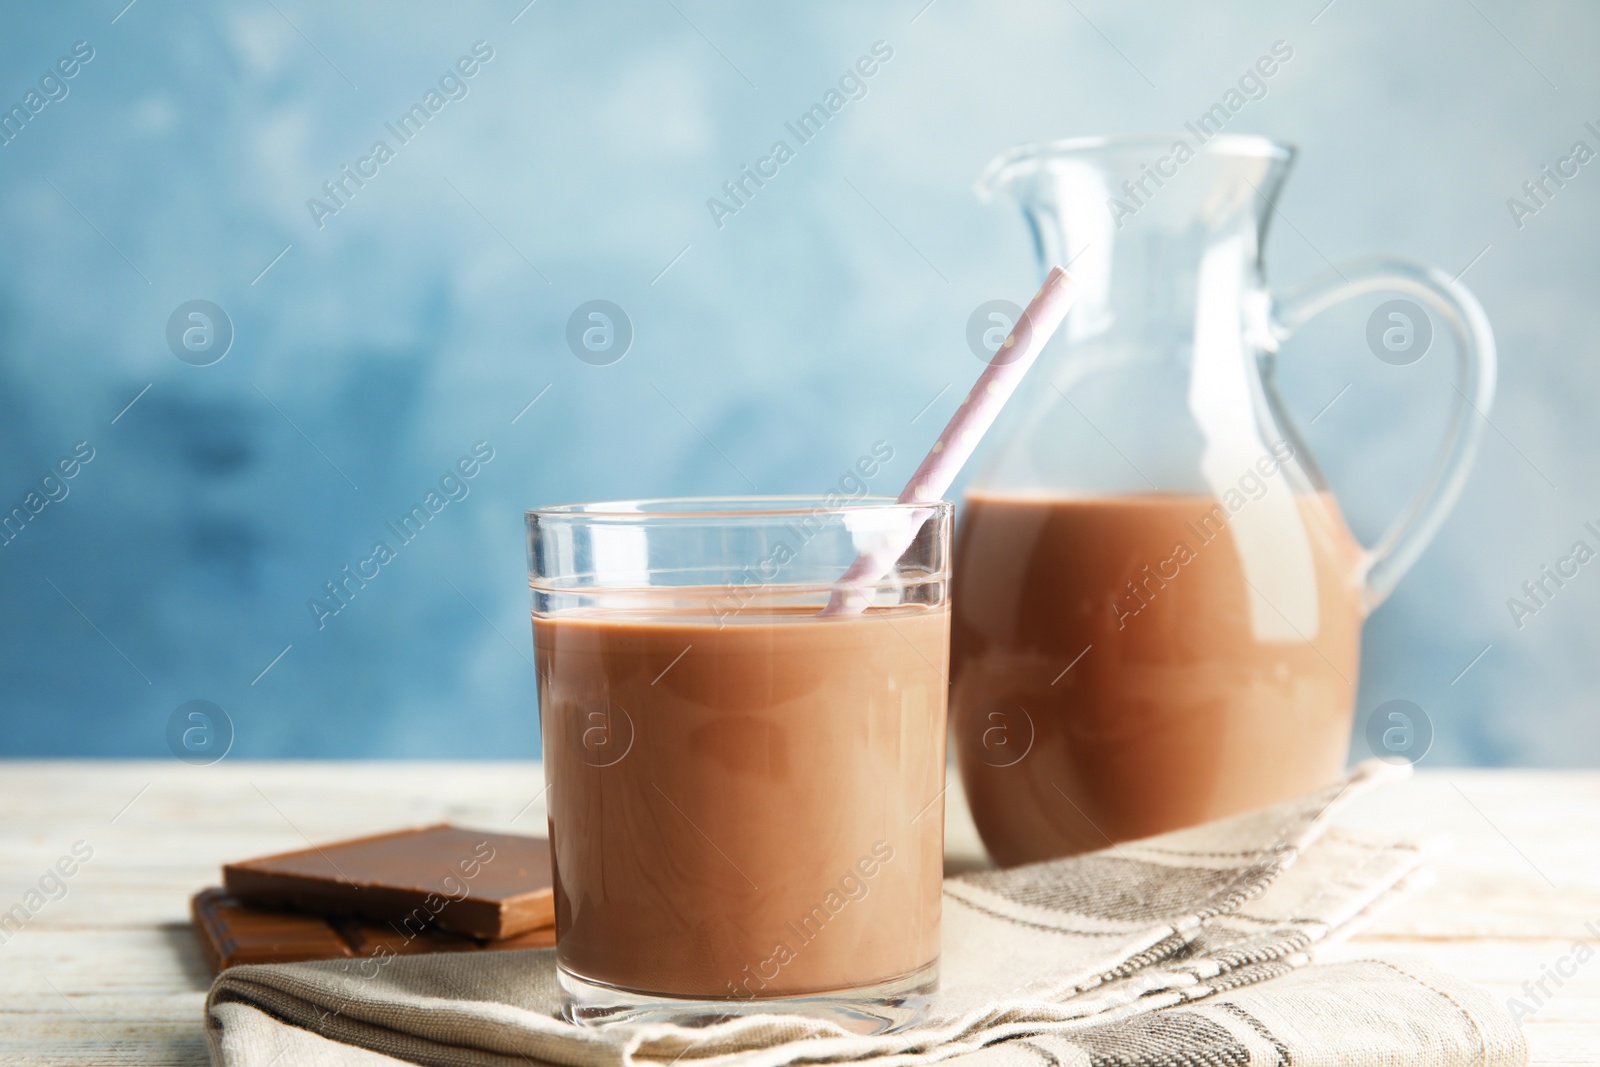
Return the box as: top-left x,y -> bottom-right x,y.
206,761 -> 1528,1067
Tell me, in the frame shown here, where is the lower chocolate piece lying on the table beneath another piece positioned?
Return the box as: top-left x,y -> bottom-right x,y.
190,889 -> 555,974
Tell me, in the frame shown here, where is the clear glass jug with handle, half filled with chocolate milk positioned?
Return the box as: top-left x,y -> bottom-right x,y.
950,136 -> 1494,865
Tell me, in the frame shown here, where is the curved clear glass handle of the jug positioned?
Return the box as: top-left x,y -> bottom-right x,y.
1272,258 -> 1496,611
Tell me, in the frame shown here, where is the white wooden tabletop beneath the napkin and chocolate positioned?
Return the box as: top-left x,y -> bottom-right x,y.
0,761 -> 1600,1064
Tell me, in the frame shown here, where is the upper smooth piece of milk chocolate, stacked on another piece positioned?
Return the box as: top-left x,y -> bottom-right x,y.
222,825 -> 555,941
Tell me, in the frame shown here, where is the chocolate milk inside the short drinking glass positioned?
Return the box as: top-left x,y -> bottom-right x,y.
533,608 -> 949,1000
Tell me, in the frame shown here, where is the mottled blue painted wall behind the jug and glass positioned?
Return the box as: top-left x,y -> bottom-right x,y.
0,0 -> 1600,765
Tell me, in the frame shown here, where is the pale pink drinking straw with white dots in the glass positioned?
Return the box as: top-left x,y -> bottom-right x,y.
822,267 -> 1078,614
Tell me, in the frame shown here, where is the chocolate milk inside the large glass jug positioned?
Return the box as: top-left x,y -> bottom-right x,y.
950,483 -> 1363,865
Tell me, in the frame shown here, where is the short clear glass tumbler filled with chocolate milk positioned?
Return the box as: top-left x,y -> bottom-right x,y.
526,496 -> 952,1032
